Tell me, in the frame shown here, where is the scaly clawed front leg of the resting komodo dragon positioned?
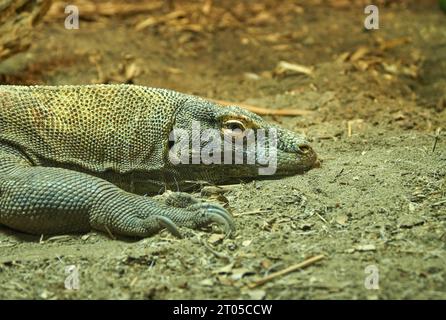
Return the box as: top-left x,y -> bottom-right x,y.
0,152 -> 234,237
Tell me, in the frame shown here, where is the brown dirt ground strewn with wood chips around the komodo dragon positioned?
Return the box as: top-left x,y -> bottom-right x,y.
0,0 -> 446,299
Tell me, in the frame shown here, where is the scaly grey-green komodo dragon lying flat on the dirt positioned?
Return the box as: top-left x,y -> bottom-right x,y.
0,85 -> 318,237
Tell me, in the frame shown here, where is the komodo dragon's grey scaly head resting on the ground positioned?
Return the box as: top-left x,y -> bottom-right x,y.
166,96 -> 319,183
